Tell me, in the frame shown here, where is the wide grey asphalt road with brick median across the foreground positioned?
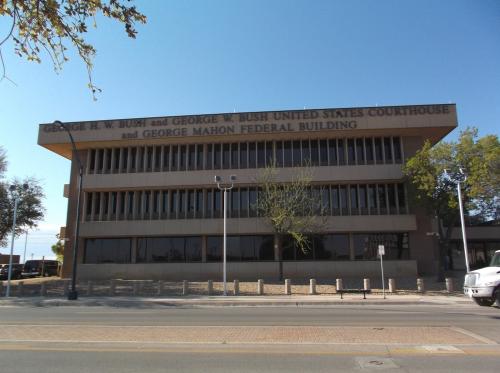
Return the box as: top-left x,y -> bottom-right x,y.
0,303 -> 500,373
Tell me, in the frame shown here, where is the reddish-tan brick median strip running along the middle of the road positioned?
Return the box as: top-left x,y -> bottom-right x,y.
0,325 -> 486,344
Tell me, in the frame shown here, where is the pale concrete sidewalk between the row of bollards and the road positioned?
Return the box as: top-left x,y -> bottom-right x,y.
0,293 -> 474,308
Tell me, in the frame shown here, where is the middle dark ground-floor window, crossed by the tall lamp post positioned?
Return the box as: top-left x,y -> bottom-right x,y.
207,236 -> 274,262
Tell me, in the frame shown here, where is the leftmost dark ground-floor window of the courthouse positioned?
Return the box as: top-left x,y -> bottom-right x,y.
84,238 -> 131,264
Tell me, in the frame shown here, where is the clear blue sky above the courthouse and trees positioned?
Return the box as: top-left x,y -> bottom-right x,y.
0,0 -> 500,257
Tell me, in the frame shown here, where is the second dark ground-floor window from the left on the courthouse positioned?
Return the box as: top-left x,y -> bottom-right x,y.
136,236 -> 201,263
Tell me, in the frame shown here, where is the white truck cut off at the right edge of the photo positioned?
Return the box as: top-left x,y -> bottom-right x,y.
464,250 -> 500,307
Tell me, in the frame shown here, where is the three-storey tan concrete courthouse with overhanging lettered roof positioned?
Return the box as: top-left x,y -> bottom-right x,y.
38,104 -> 468,280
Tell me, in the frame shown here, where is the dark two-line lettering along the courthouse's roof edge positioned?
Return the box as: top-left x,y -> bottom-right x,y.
42,104 -> 454,139
